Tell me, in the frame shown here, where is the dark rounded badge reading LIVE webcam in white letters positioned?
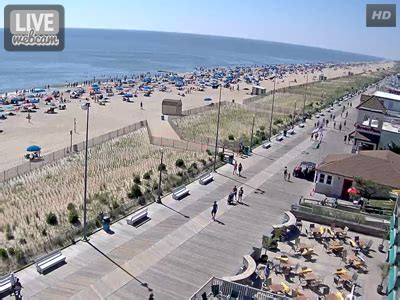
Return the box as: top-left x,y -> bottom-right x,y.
4,5 -> 64,51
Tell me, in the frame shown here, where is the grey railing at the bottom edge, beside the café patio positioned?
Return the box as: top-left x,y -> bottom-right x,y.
189,277 -> 290,300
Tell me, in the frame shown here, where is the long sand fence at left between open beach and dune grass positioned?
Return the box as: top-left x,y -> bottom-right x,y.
0,121 -> 147,182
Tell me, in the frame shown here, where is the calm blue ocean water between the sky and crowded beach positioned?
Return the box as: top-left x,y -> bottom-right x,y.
0,29 -> 380,92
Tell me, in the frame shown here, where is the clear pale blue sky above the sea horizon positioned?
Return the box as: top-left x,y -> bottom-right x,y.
0,0 -> 400,60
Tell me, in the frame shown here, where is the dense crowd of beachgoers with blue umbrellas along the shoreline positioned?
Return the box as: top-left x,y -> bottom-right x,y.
0,63 -> 368,121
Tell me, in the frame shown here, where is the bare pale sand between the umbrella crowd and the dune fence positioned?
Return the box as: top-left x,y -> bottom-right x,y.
0,62 -> 393,171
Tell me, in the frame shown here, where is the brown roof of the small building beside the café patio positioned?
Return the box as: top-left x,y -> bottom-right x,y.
317,150 -> 400,188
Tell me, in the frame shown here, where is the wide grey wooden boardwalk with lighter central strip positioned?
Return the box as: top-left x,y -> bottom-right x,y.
10,94 -> 368,300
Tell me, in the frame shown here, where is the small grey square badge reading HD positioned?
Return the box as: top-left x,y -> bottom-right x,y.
366,4 -> 396,27
